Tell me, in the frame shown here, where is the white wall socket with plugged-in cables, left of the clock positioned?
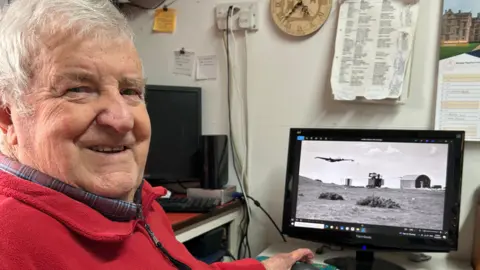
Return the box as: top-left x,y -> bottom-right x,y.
215,2 -> 259,31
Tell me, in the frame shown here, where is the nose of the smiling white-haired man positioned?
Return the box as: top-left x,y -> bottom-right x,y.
96,94 -> 134,134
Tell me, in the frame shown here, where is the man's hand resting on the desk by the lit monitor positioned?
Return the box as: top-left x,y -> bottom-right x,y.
262,248 -> 314,270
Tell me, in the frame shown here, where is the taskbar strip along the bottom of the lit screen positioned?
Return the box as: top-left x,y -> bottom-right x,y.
290,219 -> 448,240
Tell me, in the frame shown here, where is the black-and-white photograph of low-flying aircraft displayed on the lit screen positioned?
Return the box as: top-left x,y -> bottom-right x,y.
296,141 -> 448,230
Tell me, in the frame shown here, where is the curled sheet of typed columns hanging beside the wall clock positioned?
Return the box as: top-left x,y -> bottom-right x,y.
330,0 -> 419,100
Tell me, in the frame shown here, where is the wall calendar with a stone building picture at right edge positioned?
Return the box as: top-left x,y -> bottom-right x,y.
435,0 -> 480,142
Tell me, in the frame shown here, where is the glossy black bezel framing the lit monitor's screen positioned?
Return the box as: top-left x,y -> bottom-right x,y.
282,128 -> 465,252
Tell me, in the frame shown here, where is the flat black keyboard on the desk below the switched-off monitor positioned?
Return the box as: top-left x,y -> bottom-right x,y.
157,197 -> 220,213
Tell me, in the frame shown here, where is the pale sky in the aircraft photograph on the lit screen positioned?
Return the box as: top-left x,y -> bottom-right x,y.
299,141 -> 448,188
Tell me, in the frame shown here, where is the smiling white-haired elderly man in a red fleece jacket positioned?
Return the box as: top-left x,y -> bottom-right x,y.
0,0 -> 313,270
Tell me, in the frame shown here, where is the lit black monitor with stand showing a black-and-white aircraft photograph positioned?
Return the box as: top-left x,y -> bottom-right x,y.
282,128 -> 465,270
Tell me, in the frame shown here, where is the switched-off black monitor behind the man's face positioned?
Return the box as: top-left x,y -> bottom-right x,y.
144,85 -> 202,186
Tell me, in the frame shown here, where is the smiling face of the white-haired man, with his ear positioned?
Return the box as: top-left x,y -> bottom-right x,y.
7,35 -> 150,200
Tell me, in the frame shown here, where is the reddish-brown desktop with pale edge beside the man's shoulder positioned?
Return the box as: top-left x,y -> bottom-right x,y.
167,200 -> 242,231
